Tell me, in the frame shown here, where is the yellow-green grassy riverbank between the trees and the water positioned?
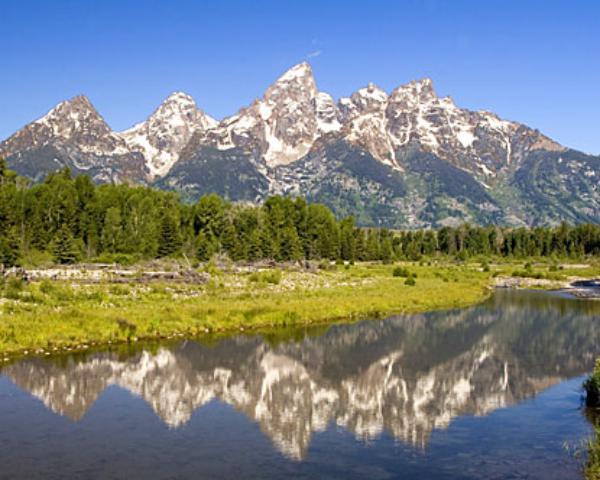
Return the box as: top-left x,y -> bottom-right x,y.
0,262 -> 591,360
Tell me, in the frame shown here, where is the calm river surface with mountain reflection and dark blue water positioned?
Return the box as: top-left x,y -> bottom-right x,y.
0,291 -> 600,480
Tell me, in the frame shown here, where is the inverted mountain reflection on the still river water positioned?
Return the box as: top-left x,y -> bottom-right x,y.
0,291 -> 600,459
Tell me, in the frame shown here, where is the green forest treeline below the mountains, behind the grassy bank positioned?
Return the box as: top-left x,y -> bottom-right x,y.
0,159 -> 600,266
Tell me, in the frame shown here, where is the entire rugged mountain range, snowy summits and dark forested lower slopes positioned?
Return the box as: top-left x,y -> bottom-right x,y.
0,63 -> 600,228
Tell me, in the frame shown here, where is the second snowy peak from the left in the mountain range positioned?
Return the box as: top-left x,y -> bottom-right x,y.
120,92 -> 217,176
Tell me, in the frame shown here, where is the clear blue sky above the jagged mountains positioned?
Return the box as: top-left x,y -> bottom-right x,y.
0,0 -> 600,154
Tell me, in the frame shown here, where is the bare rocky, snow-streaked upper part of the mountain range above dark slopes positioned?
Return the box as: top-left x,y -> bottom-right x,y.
0,66 -> 563,189
